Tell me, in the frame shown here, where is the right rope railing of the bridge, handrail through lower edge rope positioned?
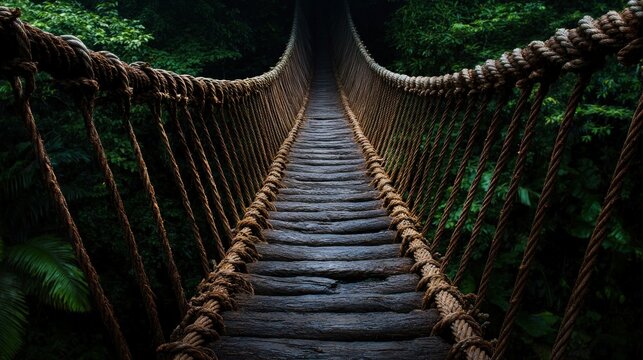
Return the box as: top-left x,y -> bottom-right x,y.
332,1 -> 643,359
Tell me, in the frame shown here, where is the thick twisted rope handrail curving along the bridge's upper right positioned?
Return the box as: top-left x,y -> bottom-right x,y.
344,0 -> 643,94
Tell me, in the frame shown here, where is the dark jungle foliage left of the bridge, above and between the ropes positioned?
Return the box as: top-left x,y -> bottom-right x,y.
0,0 -> 293,359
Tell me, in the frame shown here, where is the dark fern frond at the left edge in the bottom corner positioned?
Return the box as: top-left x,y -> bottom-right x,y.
0,269 -> 29,360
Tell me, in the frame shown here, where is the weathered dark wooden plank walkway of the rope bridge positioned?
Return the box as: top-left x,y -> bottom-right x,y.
215,64 -> 449,359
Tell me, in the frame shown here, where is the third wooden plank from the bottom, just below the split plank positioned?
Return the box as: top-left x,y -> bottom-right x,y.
235,292 -> 424,313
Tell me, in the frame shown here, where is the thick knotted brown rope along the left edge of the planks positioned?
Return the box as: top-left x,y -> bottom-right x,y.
158,96 -> 308,360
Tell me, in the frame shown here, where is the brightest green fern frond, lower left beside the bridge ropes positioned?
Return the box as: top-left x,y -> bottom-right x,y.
6,235 -> 90,312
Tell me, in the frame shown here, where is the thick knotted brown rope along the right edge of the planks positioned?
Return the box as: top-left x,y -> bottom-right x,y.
338,81 -> 489,359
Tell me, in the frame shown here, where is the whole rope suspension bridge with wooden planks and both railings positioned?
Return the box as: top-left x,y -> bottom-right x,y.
0,1 -> 643,359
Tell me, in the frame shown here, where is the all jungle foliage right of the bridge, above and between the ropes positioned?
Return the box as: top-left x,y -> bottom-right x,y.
378,0 -> 643,359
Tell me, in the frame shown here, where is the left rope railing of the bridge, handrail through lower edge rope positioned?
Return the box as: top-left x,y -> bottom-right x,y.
0,3 -> 312,359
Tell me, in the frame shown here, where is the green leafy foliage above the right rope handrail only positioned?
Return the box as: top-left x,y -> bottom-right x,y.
387,0 -> 624,75
